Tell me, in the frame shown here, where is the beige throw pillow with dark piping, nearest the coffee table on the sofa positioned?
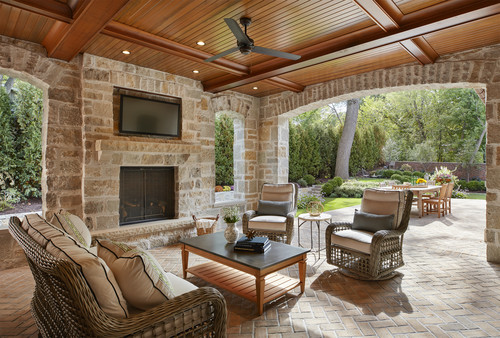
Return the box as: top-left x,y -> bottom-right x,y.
97,240 -> 182,310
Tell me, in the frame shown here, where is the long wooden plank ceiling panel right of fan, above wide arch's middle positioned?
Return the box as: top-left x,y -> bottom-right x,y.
281,44 -> 416,86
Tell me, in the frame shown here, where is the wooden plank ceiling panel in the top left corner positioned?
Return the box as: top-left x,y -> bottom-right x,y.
0,4 -> 56,43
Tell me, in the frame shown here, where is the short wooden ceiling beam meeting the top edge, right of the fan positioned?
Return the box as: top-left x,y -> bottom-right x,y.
354,0 -> 403,32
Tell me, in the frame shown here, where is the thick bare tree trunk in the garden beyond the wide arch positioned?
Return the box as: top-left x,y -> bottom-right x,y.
335,98 -> 361,180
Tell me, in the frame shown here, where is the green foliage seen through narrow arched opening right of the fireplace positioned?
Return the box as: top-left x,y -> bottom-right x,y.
215,114 -> 234,185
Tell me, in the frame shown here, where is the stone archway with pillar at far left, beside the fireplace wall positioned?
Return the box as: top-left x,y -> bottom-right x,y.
0,36 -> 83,219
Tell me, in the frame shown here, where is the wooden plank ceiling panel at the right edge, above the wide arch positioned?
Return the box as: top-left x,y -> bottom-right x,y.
425,15 -> 500,55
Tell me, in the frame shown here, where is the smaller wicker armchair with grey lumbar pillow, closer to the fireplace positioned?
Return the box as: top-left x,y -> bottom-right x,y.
242,183 -> 299,244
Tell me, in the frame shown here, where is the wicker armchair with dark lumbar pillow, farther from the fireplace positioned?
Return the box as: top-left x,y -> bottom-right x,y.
325,189 -> 413,280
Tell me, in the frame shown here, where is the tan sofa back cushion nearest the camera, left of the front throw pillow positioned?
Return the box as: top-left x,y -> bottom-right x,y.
47,236 -> 128,318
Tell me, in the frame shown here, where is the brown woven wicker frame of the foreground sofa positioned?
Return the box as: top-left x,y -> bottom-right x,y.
9,217 -> 227,337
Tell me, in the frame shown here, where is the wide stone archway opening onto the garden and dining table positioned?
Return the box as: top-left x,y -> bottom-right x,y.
259,45 -> 500,262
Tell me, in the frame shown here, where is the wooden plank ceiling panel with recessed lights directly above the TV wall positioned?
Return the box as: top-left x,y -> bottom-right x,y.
87,35 -> 225,81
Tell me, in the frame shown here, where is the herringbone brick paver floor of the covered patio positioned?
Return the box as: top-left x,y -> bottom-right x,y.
0,200 -> 500,338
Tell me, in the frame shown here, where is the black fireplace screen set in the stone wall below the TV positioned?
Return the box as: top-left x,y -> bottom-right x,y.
120,167 -> 175,225
